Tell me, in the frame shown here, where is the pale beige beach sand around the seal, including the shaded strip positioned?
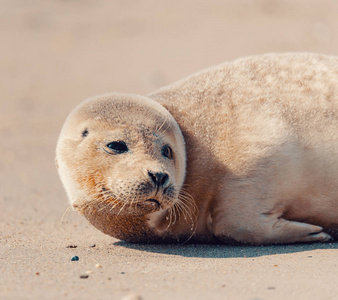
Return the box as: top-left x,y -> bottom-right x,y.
0,0 -> 338,300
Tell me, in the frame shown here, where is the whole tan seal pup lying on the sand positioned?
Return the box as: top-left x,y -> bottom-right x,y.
56,53 -> 338,245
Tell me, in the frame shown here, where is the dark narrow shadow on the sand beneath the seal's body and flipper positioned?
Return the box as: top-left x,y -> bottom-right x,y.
114,241 -> 338,258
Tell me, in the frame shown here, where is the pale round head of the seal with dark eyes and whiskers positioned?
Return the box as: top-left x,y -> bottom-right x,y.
56,94 -> 186,224
